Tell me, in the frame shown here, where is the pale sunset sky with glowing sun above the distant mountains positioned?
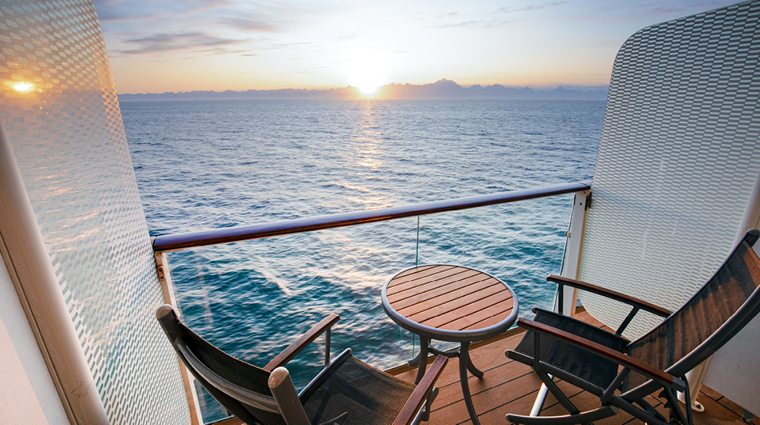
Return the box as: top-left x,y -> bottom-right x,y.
95,0 -> 736,93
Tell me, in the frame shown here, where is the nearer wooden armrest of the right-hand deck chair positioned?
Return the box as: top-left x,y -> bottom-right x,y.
517,319 -> 683,390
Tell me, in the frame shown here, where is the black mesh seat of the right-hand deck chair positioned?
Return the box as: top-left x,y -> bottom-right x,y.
514,308 -> 629,388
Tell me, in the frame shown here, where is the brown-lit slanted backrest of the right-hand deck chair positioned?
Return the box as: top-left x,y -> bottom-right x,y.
627,229 -> 760,388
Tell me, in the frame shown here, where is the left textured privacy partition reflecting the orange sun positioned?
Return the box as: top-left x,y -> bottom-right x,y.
0,0 -> 190,424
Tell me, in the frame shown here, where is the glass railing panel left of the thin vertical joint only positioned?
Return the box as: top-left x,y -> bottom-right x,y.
169,217 -> 424,422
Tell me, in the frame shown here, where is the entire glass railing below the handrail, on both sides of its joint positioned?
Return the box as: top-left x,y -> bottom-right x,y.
163,195 -> 573,422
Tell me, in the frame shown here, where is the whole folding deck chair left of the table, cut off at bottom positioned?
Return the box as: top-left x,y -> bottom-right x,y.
156,305 -> 448,425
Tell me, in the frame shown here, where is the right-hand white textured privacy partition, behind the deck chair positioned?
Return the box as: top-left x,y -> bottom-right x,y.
578,0 -> 760,339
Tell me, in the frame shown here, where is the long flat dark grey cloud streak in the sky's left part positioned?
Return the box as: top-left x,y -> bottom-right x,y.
121,32 -> 244,54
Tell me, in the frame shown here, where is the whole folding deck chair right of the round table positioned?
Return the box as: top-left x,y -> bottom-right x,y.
506,229 -> 760,424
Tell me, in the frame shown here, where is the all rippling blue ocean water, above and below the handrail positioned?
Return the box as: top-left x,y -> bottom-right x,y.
121,100 -> 604,419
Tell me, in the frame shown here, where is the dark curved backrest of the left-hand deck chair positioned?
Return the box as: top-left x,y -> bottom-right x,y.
156,305 -> 285,425
